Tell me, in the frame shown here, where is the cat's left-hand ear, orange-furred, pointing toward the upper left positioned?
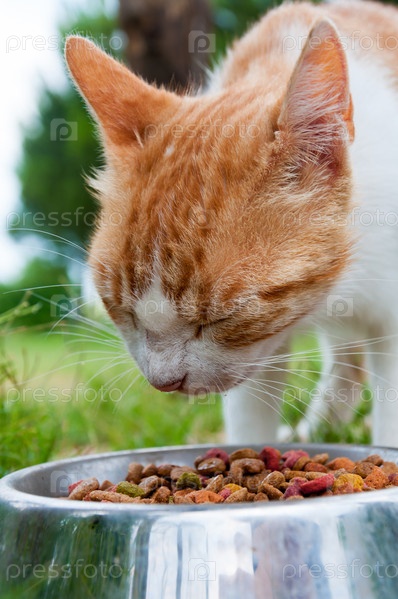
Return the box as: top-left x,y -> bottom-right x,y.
65,36 -> 181,148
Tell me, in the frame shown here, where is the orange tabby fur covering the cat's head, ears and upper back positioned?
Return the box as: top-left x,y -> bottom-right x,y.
66,3 -> 397,348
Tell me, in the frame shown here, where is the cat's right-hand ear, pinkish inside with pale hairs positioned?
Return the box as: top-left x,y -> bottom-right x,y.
278,20 -> 354,157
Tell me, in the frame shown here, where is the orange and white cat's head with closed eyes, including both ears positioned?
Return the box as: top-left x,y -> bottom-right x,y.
66,21 -> 353,393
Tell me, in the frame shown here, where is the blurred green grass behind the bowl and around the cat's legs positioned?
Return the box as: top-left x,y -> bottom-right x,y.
0,304 -> 371,475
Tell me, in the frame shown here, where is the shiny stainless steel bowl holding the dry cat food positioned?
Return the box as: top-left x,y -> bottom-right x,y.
0,444 -> 398,599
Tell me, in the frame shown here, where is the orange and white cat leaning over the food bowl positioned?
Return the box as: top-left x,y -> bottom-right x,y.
66,2 -> 398,446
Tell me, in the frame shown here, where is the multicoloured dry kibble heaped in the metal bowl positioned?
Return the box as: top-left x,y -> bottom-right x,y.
68,447 -> 398,504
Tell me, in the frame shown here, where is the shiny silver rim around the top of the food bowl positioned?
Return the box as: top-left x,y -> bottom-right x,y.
0,443 -> 398,516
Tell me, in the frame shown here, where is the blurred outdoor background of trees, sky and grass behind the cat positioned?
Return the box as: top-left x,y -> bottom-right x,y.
0,0 -> 384,476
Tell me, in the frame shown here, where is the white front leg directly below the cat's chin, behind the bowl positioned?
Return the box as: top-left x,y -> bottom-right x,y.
224,362 -> 286,445
